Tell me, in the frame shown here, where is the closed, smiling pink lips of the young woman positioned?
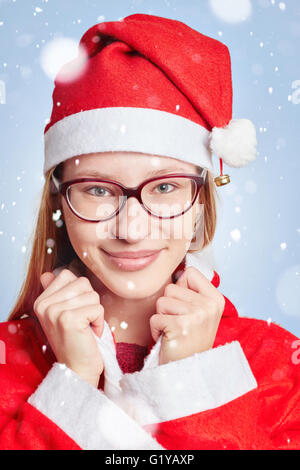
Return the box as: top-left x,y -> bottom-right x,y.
103,250 -> 162,271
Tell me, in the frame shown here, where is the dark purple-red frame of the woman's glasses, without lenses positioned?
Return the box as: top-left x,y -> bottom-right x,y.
52,168 -> 207,222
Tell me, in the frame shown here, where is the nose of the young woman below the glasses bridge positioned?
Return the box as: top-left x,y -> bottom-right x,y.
113,197 -> 151,243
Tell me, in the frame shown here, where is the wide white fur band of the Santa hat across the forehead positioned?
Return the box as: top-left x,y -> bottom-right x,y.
43,107 -> 213,175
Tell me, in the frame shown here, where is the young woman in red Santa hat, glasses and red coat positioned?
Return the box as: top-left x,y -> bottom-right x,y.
0,14 -> 300,450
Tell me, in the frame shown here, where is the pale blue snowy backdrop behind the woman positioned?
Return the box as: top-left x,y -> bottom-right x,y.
0,0 -> 300,336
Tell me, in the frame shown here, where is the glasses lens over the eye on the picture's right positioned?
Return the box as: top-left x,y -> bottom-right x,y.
142,177 -> 197,217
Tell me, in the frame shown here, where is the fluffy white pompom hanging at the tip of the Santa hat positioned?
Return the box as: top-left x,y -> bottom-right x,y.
210,119 -> 257,167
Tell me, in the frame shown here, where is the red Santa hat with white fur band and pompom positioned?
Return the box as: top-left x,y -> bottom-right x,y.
44,14 -> 256,185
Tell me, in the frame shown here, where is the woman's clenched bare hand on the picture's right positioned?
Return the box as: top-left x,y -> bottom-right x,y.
150,267 -> 225,364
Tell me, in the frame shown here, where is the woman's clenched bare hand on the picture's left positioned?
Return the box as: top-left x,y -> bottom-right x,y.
33,269 -> 104,388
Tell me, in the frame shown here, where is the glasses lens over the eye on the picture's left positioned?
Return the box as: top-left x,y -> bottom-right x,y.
67,182 -> 123,220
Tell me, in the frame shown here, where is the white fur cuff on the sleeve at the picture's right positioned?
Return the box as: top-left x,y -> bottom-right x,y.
120,341 -> 257,425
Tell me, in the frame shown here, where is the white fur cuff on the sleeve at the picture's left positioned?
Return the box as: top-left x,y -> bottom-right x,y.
28,363 -> 163,450
